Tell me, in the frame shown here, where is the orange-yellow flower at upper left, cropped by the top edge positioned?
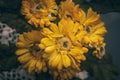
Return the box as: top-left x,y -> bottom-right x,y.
21,0 -> 57,27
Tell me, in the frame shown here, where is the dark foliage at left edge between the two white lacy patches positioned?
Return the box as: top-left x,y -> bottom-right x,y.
0,44 -> 19,72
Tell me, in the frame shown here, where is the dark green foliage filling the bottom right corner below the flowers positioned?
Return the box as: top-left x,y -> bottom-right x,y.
81,50 -> 120,80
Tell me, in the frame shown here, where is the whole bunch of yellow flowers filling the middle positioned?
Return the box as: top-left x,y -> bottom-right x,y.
16,0 -> 107,80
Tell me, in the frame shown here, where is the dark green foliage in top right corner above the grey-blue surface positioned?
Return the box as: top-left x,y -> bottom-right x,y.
73,0 -> 120,13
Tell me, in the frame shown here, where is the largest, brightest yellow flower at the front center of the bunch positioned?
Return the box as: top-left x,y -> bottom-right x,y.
39,19 -> 88,71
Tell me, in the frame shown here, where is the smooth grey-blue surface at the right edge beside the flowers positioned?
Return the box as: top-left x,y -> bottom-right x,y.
102,12 -> 120,66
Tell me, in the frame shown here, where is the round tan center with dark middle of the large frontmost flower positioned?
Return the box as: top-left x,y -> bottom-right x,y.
58,37 -> 72,50
